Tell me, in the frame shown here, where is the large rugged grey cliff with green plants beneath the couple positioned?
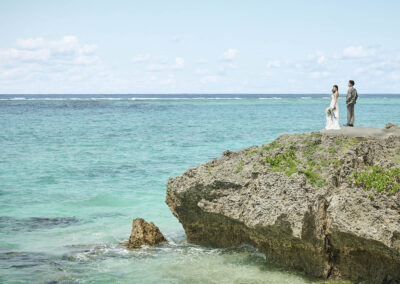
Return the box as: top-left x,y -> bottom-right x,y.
166,126 -> 400,283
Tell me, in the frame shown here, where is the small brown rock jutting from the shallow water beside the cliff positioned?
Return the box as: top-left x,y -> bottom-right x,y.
124,218 -> 167,248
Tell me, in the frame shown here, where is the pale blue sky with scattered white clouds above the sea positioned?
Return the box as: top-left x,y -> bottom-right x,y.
0,0 -> 400,94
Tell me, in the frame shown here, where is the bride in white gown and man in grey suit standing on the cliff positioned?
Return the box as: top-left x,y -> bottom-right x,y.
325,80 -> 358,130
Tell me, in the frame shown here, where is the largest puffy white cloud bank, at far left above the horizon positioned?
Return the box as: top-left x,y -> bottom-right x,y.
0,36 -> 106,92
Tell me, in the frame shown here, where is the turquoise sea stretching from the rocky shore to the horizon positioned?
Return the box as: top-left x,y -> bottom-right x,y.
0,95 -> 400,283
